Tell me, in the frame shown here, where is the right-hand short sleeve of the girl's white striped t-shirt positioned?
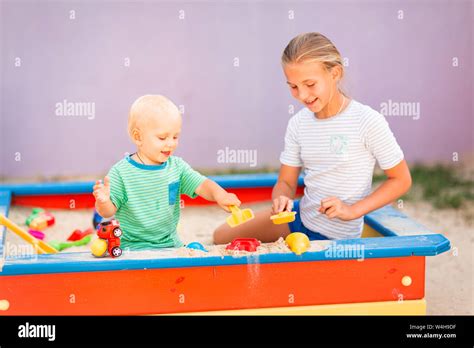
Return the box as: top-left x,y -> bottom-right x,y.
362,112 -> 404,170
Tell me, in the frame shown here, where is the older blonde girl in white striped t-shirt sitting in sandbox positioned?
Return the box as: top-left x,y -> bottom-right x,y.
214,33 -> 411,244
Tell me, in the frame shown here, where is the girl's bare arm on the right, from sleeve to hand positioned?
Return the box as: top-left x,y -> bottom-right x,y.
319,160 -> 412,220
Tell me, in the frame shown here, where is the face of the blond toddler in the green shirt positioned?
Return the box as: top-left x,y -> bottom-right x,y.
135,113 -> 182,164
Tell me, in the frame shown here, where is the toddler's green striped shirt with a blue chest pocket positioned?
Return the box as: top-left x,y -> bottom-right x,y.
108,156 -> 206,250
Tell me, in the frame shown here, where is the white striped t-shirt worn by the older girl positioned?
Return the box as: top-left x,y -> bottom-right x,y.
280,100 -> 404,239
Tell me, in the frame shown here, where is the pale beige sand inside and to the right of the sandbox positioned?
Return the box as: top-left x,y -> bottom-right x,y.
1,198 -> 474,315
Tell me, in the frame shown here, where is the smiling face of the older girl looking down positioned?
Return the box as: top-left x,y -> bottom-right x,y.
283,61 -> 341,114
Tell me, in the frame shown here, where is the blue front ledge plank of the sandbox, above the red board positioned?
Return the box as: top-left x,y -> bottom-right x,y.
0,234 -> 450,275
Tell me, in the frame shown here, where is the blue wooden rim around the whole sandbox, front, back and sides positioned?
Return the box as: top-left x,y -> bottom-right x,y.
0,174 -> 450,275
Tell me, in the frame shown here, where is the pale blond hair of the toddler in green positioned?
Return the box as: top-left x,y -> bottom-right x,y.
128,94 -> 180,137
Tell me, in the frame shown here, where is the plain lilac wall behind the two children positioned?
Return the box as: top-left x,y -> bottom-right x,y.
0,1 -> 473,177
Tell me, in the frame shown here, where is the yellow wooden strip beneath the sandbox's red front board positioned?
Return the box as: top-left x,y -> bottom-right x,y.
173,298 -> 426,315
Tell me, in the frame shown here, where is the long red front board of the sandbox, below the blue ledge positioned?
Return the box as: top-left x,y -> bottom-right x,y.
0,256 -> 425,315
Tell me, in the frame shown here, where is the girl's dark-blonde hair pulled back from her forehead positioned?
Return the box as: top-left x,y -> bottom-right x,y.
281,33 -> 344,94
